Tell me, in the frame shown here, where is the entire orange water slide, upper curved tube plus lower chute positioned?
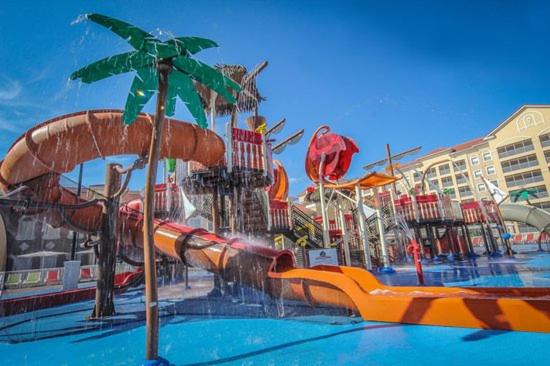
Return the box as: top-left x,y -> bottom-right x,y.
0,110 -> 550,332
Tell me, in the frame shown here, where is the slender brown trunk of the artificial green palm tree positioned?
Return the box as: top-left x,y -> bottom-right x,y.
143,62 -> 172,360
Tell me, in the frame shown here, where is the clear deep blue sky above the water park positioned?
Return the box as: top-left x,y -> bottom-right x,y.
0,0 -> 550,195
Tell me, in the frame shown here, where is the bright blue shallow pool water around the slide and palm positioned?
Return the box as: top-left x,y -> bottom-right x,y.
0,254 -> 550,365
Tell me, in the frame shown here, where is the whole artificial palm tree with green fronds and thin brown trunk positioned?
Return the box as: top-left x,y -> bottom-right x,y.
71,14 -> 240,360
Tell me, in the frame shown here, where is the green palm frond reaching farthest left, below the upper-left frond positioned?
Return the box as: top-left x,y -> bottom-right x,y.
71,51 -> 155,83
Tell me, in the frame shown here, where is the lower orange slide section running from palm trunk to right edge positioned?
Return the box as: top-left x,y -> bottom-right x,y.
119,207 -> 550,332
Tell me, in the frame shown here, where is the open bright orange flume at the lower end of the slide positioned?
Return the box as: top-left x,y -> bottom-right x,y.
269,266 -> 550,332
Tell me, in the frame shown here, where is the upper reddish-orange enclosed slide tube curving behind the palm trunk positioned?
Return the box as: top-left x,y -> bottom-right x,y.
0,110 -> 225,231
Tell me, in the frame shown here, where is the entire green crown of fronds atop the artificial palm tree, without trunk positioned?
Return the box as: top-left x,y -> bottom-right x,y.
71,14 -> 241,128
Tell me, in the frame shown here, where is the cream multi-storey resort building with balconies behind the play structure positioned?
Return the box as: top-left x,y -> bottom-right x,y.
397,105 -> 550,233
